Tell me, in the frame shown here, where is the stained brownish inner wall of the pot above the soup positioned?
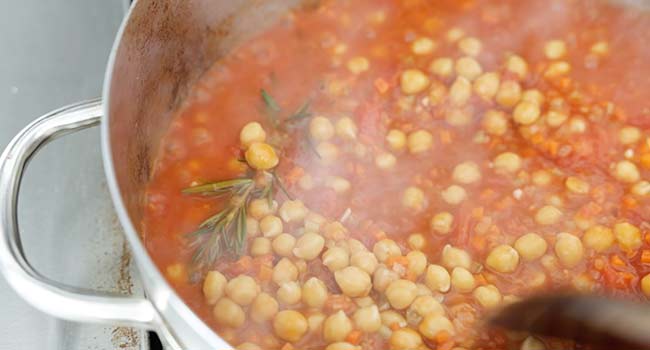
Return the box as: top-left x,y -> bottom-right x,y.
108,0 -> 313,228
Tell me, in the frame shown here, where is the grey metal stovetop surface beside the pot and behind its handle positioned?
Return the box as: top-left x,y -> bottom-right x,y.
0,0 -> 146,350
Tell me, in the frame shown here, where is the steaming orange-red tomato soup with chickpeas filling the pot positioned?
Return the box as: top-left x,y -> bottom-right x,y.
143,0 -> 650,350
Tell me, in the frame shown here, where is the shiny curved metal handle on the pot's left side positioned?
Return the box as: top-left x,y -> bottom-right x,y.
0,99 -> 160,329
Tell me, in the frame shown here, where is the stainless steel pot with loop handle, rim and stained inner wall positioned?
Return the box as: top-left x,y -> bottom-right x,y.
0,0 -> 305,349
